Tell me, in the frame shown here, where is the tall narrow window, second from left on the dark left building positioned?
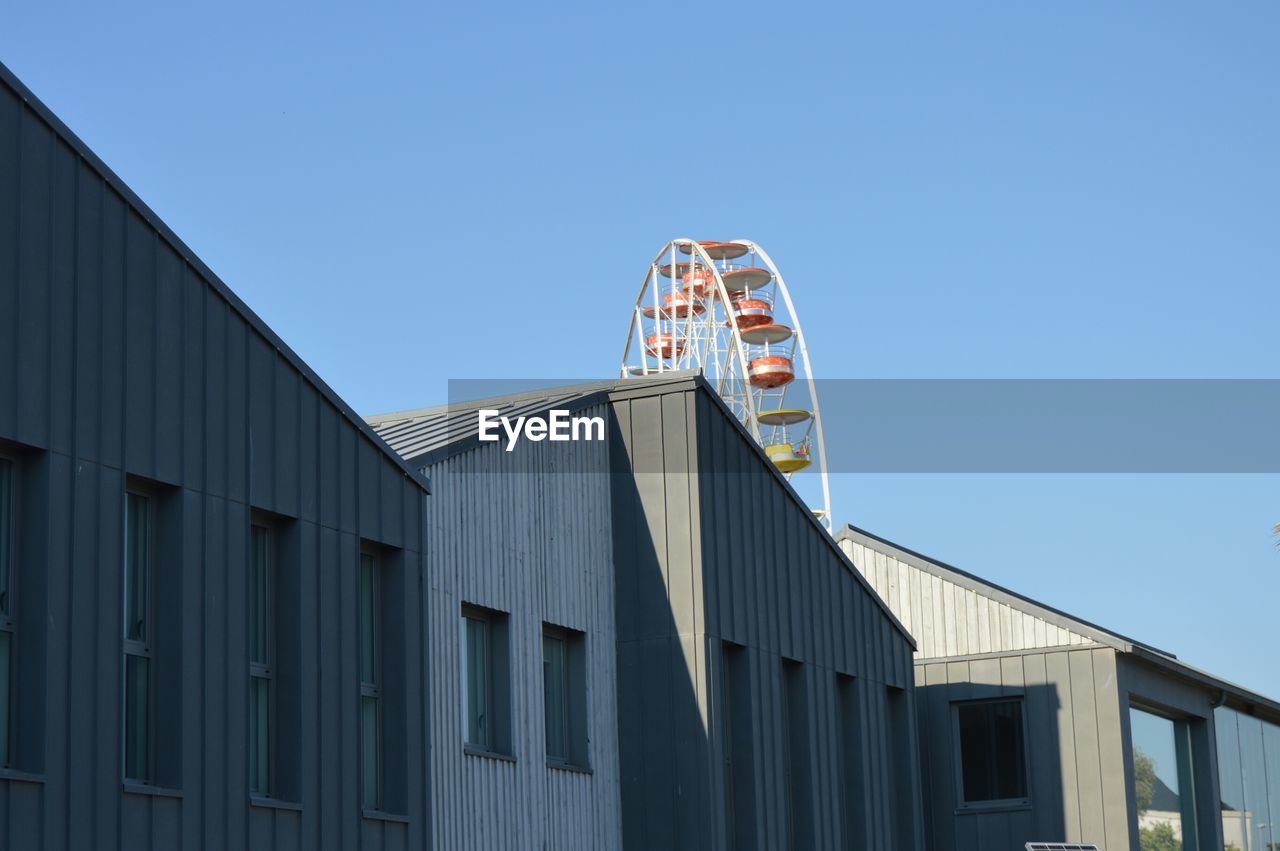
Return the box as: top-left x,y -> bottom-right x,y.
124,491 -> 154,783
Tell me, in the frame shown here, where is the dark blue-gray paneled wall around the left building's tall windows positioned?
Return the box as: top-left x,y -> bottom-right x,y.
0,69 -> 428,850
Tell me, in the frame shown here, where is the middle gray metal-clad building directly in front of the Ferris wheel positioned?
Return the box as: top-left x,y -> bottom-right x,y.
370,372 -> 922,851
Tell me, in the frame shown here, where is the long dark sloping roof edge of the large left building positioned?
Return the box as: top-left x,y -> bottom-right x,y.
0,63 -> 430,491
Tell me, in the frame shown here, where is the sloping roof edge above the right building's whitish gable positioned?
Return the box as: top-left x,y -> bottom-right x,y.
836,523 -> 1280,720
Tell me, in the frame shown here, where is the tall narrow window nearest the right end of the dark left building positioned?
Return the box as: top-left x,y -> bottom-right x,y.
360,553 -> 383,810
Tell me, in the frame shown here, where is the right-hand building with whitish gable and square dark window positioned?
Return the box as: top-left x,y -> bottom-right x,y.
836,526 -> 1280,851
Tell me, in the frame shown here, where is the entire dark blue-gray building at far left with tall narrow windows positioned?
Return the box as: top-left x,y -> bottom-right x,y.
0,61 -> 430,851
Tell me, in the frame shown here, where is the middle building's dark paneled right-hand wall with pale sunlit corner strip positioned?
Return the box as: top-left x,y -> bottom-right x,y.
614,392 -> 920,851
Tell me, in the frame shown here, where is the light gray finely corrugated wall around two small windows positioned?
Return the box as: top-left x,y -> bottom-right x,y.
426,406 -> 621,851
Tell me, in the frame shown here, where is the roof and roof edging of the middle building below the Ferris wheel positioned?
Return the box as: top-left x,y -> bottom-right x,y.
369,370 -> 916,649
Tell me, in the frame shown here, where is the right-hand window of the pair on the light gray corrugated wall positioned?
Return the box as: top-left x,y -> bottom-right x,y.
543,623 -> 589,768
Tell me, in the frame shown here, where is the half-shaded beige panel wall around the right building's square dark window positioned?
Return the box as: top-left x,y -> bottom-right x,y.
915,646 -> 1129,851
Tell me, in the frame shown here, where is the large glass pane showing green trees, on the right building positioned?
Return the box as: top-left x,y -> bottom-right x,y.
1129,706 -> 1197,851
